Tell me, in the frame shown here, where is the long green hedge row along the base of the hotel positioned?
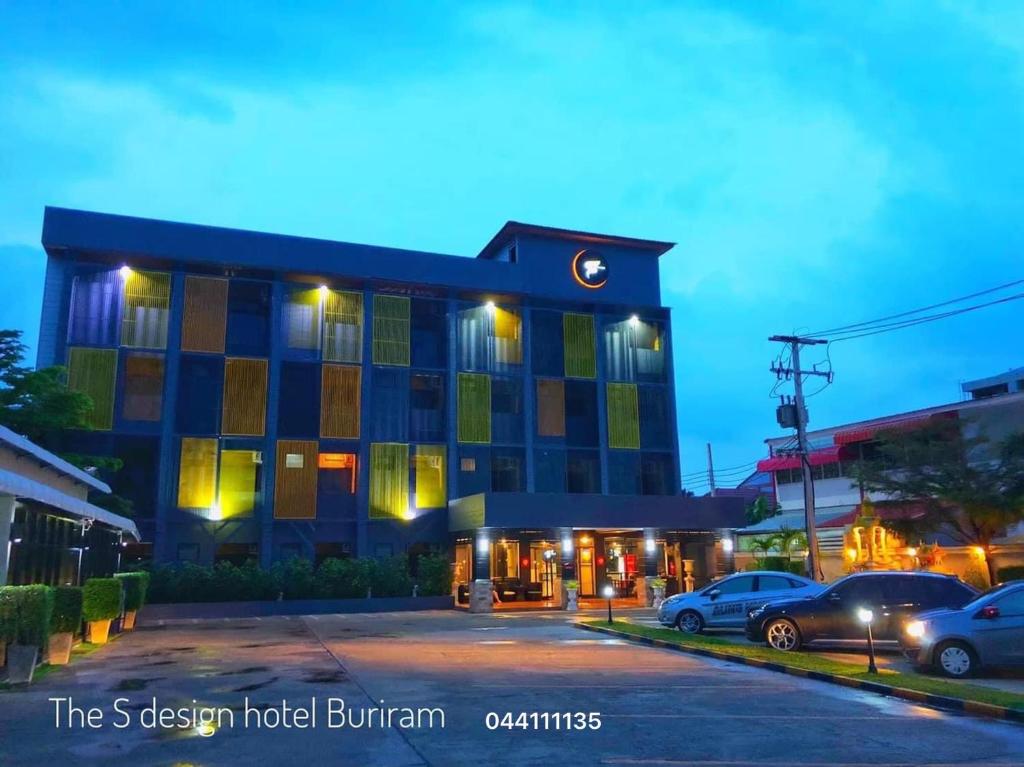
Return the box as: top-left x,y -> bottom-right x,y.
148,554 -> 452,603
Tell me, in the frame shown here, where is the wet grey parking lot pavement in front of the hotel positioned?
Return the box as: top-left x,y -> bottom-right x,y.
0,611 -> 1024,767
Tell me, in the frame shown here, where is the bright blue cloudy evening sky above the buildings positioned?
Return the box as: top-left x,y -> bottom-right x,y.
0,0 -> 1024,489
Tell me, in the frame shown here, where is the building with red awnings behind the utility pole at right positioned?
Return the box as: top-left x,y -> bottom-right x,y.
739,379 -> 1024,577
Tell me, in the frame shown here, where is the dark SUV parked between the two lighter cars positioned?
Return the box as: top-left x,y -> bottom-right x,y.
746,572 -> 978,650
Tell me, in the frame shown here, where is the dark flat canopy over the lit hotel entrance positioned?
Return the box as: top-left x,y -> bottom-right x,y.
449,493 -> 745,532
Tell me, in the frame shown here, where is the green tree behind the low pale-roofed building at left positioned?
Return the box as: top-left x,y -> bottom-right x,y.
0,330 -> 132,516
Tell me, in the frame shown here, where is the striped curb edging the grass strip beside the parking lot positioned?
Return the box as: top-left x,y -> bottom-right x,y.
577,623 -> 1024,723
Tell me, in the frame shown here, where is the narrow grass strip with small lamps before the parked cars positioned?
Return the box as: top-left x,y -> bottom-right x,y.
583,620 -> 1024,712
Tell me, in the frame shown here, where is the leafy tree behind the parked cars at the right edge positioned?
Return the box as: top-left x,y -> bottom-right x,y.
854,420 -> 1024,584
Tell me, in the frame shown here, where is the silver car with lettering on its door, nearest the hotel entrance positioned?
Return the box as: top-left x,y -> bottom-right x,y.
657,570 -> 825,634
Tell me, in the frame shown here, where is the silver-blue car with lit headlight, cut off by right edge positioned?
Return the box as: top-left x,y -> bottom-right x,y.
902,581 -> 1024,677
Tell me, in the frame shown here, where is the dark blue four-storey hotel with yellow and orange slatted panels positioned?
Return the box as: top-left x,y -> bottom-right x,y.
38,208 -> 737,594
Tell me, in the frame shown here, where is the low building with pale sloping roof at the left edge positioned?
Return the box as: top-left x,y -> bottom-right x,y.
0,426 -> 139,586
